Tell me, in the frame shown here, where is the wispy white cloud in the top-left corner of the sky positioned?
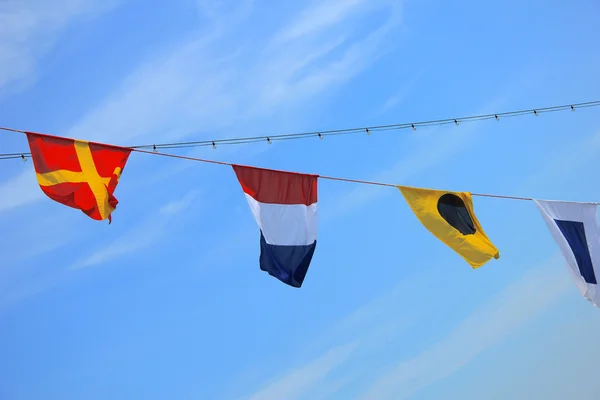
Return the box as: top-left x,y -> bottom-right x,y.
0,0 -> 119,95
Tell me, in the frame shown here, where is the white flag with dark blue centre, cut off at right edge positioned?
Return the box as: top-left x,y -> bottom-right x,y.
535,200 -> 600,307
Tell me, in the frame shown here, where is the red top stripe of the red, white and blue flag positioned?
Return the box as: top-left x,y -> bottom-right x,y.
232,165 -> 318,206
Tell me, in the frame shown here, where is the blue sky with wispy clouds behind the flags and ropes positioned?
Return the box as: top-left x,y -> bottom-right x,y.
0,0 -> 600,400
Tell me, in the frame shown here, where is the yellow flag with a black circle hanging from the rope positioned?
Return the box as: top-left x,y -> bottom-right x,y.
398,186 -> 500,268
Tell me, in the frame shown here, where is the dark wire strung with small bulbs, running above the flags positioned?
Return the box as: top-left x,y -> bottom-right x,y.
0,100 -> 600,160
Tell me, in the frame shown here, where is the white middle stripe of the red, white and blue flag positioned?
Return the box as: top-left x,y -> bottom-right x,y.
244,193 -> 318,246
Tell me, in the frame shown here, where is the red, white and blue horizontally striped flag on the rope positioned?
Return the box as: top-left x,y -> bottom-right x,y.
233,165 -> 318,288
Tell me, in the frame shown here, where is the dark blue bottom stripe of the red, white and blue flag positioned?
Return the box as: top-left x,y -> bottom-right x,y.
260,231 -> 317,288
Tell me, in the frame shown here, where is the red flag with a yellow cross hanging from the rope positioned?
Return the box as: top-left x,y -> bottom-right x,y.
27,132 -> 131,223
